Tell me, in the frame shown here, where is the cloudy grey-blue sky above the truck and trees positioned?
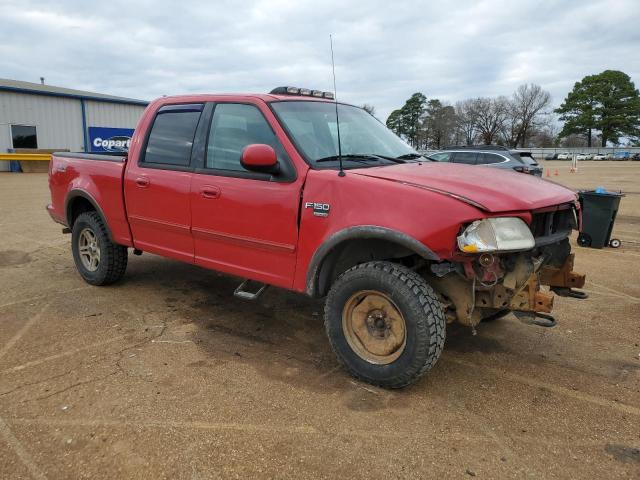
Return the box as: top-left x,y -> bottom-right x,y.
0,0 -> 640,120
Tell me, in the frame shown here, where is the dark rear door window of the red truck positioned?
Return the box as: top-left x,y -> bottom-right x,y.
144,105 -> 202,167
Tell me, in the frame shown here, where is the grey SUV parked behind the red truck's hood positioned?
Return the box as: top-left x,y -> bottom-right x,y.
428,145 -> 542,177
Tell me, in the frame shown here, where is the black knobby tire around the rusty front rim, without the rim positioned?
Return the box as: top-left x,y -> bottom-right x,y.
324,261 -> 446,388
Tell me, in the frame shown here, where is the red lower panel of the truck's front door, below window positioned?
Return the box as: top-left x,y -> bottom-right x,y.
191,174 -> 300,288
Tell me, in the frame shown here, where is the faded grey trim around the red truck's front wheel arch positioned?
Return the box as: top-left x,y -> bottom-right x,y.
307,225 -> 440,297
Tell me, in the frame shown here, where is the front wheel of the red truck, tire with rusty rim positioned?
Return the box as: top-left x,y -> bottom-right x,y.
325,261 -> 446,388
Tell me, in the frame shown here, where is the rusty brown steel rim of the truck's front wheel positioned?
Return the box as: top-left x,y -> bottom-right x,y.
342,290 -> 407,365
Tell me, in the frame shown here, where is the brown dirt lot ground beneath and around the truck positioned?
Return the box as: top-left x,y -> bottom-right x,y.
0,162 -> 640,479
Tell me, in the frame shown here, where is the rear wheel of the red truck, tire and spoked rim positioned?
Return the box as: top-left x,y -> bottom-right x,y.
71,212 -> 127,285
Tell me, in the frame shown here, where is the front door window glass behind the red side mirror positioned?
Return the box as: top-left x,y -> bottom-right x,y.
205,103 -> 286,171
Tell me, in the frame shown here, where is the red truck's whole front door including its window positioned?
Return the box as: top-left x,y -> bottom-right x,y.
191,103 -> 302,287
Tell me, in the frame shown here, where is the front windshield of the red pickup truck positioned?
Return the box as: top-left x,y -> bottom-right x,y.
271,101 -> 424,168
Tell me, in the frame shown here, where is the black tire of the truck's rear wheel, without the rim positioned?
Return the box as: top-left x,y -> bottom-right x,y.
71,212 -> 127,285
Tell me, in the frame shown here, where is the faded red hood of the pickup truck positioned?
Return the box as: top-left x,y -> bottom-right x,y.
351,162 -> 576,213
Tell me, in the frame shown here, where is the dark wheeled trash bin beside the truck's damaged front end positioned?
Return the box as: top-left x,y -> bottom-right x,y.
578,188 -> 624,248
